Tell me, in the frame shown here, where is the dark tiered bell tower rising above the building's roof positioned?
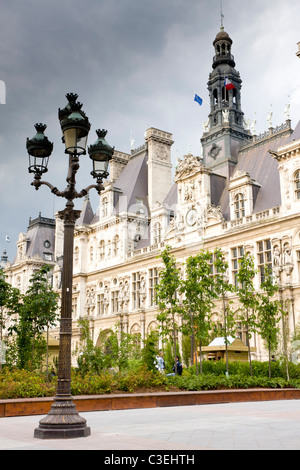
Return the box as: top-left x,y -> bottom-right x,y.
201,25 -> 251,178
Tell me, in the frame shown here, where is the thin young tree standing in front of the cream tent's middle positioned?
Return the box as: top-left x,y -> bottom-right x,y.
214,248 -> 236,376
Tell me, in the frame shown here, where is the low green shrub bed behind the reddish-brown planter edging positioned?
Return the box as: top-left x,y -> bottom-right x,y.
0,361 -> 300,399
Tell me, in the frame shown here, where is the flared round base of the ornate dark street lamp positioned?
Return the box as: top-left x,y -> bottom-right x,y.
34,398 -> 91,439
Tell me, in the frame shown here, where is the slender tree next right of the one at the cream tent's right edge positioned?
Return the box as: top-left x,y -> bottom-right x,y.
257,266 -> 280,378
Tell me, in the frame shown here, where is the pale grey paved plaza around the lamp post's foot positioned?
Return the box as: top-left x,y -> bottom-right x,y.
0,400 -> 300,452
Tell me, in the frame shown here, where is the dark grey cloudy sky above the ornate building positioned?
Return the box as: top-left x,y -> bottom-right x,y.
0,0 -> 300,260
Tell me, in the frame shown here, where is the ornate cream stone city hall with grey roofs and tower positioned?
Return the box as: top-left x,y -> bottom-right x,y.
6,28 -> 300,359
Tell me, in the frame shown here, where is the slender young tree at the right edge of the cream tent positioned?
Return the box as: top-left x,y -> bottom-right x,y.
237,253 -> 257,376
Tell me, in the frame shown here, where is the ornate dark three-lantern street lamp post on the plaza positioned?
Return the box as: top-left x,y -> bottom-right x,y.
26,93 -> 114,439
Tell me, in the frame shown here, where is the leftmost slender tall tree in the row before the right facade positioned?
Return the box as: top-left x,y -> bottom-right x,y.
156,246 -> 181,373
